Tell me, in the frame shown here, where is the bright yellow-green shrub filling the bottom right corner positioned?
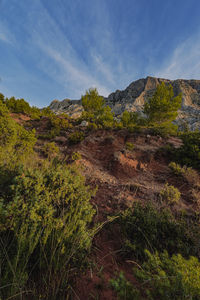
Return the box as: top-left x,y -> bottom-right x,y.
134,251 -> 200,300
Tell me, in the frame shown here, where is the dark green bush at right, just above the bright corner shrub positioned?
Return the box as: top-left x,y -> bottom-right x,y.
118,203 -> 200,260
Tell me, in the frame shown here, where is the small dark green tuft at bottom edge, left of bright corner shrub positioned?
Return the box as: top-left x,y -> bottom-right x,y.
110,272 -> 141,300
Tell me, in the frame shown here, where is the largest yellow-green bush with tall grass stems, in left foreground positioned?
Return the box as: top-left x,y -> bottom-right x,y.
0,164 -> 94,299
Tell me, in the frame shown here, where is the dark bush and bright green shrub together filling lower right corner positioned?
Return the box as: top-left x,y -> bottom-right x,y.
110,204 -> 200,300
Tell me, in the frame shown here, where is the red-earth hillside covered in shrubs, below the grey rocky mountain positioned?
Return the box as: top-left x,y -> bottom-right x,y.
0,87 -> 200,300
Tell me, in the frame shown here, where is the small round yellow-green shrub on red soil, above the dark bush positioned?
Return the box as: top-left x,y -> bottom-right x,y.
160,183 -> 181,204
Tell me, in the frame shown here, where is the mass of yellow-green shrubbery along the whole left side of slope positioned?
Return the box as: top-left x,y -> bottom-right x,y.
0,101 -> 94,299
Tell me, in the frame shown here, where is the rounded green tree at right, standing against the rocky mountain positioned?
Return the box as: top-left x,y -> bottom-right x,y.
144,82 -> 182,125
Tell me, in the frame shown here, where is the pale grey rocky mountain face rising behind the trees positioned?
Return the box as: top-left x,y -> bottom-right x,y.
50,77 -> 200,130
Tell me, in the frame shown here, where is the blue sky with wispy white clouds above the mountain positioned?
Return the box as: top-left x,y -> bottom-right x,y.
0,0 -> 200,107
